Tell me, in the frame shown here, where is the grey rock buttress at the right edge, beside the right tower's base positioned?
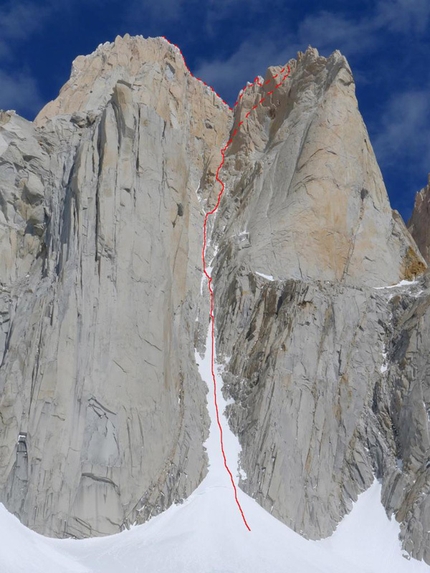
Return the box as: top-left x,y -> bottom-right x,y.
369,272 -> 430,564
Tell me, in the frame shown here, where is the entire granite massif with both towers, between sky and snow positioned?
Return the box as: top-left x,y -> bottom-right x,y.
0,37 -> 430,562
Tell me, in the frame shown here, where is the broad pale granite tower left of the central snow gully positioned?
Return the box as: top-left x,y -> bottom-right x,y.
0,38 -> 230,537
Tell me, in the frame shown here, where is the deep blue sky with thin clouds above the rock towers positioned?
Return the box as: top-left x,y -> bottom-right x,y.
0,0 -> 430,219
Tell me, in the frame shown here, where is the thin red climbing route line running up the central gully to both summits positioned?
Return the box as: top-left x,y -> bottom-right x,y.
164,34 -> 291,531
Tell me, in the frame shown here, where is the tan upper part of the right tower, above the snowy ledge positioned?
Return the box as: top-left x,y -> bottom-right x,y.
215,49 -> 425,286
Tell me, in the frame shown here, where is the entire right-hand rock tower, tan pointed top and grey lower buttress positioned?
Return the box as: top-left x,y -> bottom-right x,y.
213,49 -> 429,560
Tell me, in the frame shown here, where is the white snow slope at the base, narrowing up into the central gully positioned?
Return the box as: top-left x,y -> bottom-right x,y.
0,328 -> 430,573
